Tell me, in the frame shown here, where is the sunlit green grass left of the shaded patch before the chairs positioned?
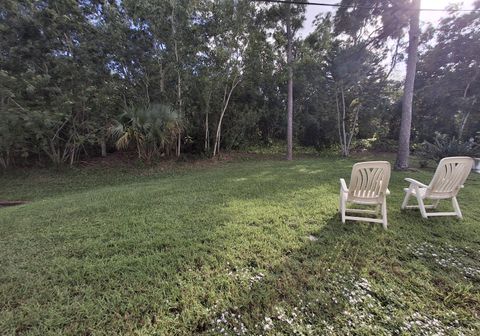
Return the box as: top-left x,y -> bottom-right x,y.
0,161 -> 348,334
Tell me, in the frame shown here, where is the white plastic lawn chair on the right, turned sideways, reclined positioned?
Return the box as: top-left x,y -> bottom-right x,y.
402,156 -> 474,218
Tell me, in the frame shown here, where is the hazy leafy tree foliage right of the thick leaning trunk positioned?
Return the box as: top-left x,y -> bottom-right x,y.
413,1 -> 480,142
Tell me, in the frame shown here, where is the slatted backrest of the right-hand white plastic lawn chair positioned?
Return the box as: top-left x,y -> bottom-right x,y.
426,156 -> 474,198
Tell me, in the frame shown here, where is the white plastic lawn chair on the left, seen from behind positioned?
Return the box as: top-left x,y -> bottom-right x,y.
340,161 -> 391,229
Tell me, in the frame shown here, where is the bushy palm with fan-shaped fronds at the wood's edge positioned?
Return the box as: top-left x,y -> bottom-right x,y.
109,104 -> 183,162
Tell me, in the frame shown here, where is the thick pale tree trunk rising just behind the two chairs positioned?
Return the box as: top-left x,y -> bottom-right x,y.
395,0 -> 421,170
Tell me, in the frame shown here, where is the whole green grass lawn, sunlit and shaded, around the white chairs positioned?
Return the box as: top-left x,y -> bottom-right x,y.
0,158 -> 480,335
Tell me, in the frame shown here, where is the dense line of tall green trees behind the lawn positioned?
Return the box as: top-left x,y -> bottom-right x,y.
0,0 -> 480,167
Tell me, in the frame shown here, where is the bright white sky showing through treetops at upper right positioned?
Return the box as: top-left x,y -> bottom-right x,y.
300,0 -> 474,37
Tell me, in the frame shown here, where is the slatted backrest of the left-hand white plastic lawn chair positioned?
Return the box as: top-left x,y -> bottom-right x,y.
348,161 -> 391,200
